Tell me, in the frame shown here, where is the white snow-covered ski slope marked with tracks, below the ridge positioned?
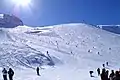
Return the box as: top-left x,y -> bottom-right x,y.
0,23 -> 120,80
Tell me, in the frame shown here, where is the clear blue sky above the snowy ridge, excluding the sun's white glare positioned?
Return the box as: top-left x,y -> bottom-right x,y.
0,0 -> 120,26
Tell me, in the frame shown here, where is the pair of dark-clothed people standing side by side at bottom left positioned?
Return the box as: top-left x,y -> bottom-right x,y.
2,68 -> 14,80
